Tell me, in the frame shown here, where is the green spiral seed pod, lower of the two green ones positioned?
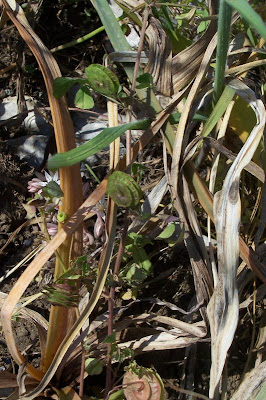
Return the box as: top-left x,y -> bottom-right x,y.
107,171 -> 142,208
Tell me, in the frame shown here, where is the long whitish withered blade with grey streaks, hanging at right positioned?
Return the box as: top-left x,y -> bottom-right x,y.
207,80 -> 265,398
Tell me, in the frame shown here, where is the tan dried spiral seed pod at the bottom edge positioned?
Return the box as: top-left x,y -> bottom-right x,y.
123,364 -> 164,400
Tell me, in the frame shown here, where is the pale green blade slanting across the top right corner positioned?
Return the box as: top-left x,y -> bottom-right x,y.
225,0 -> 266,39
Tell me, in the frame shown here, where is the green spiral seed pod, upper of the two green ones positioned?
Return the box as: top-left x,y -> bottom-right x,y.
85,64 -> 120,96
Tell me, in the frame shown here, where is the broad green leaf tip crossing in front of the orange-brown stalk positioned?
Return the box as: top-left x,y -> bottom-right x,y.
48,119 -> 151,170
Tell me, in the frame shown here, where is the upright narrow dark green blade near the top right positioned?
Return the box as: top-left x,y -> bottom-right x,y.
213,0 -> 232,105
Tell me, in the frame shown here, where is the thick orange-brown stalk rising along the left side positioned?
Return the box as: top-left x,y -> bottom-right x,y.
2,0 -> 82,369
